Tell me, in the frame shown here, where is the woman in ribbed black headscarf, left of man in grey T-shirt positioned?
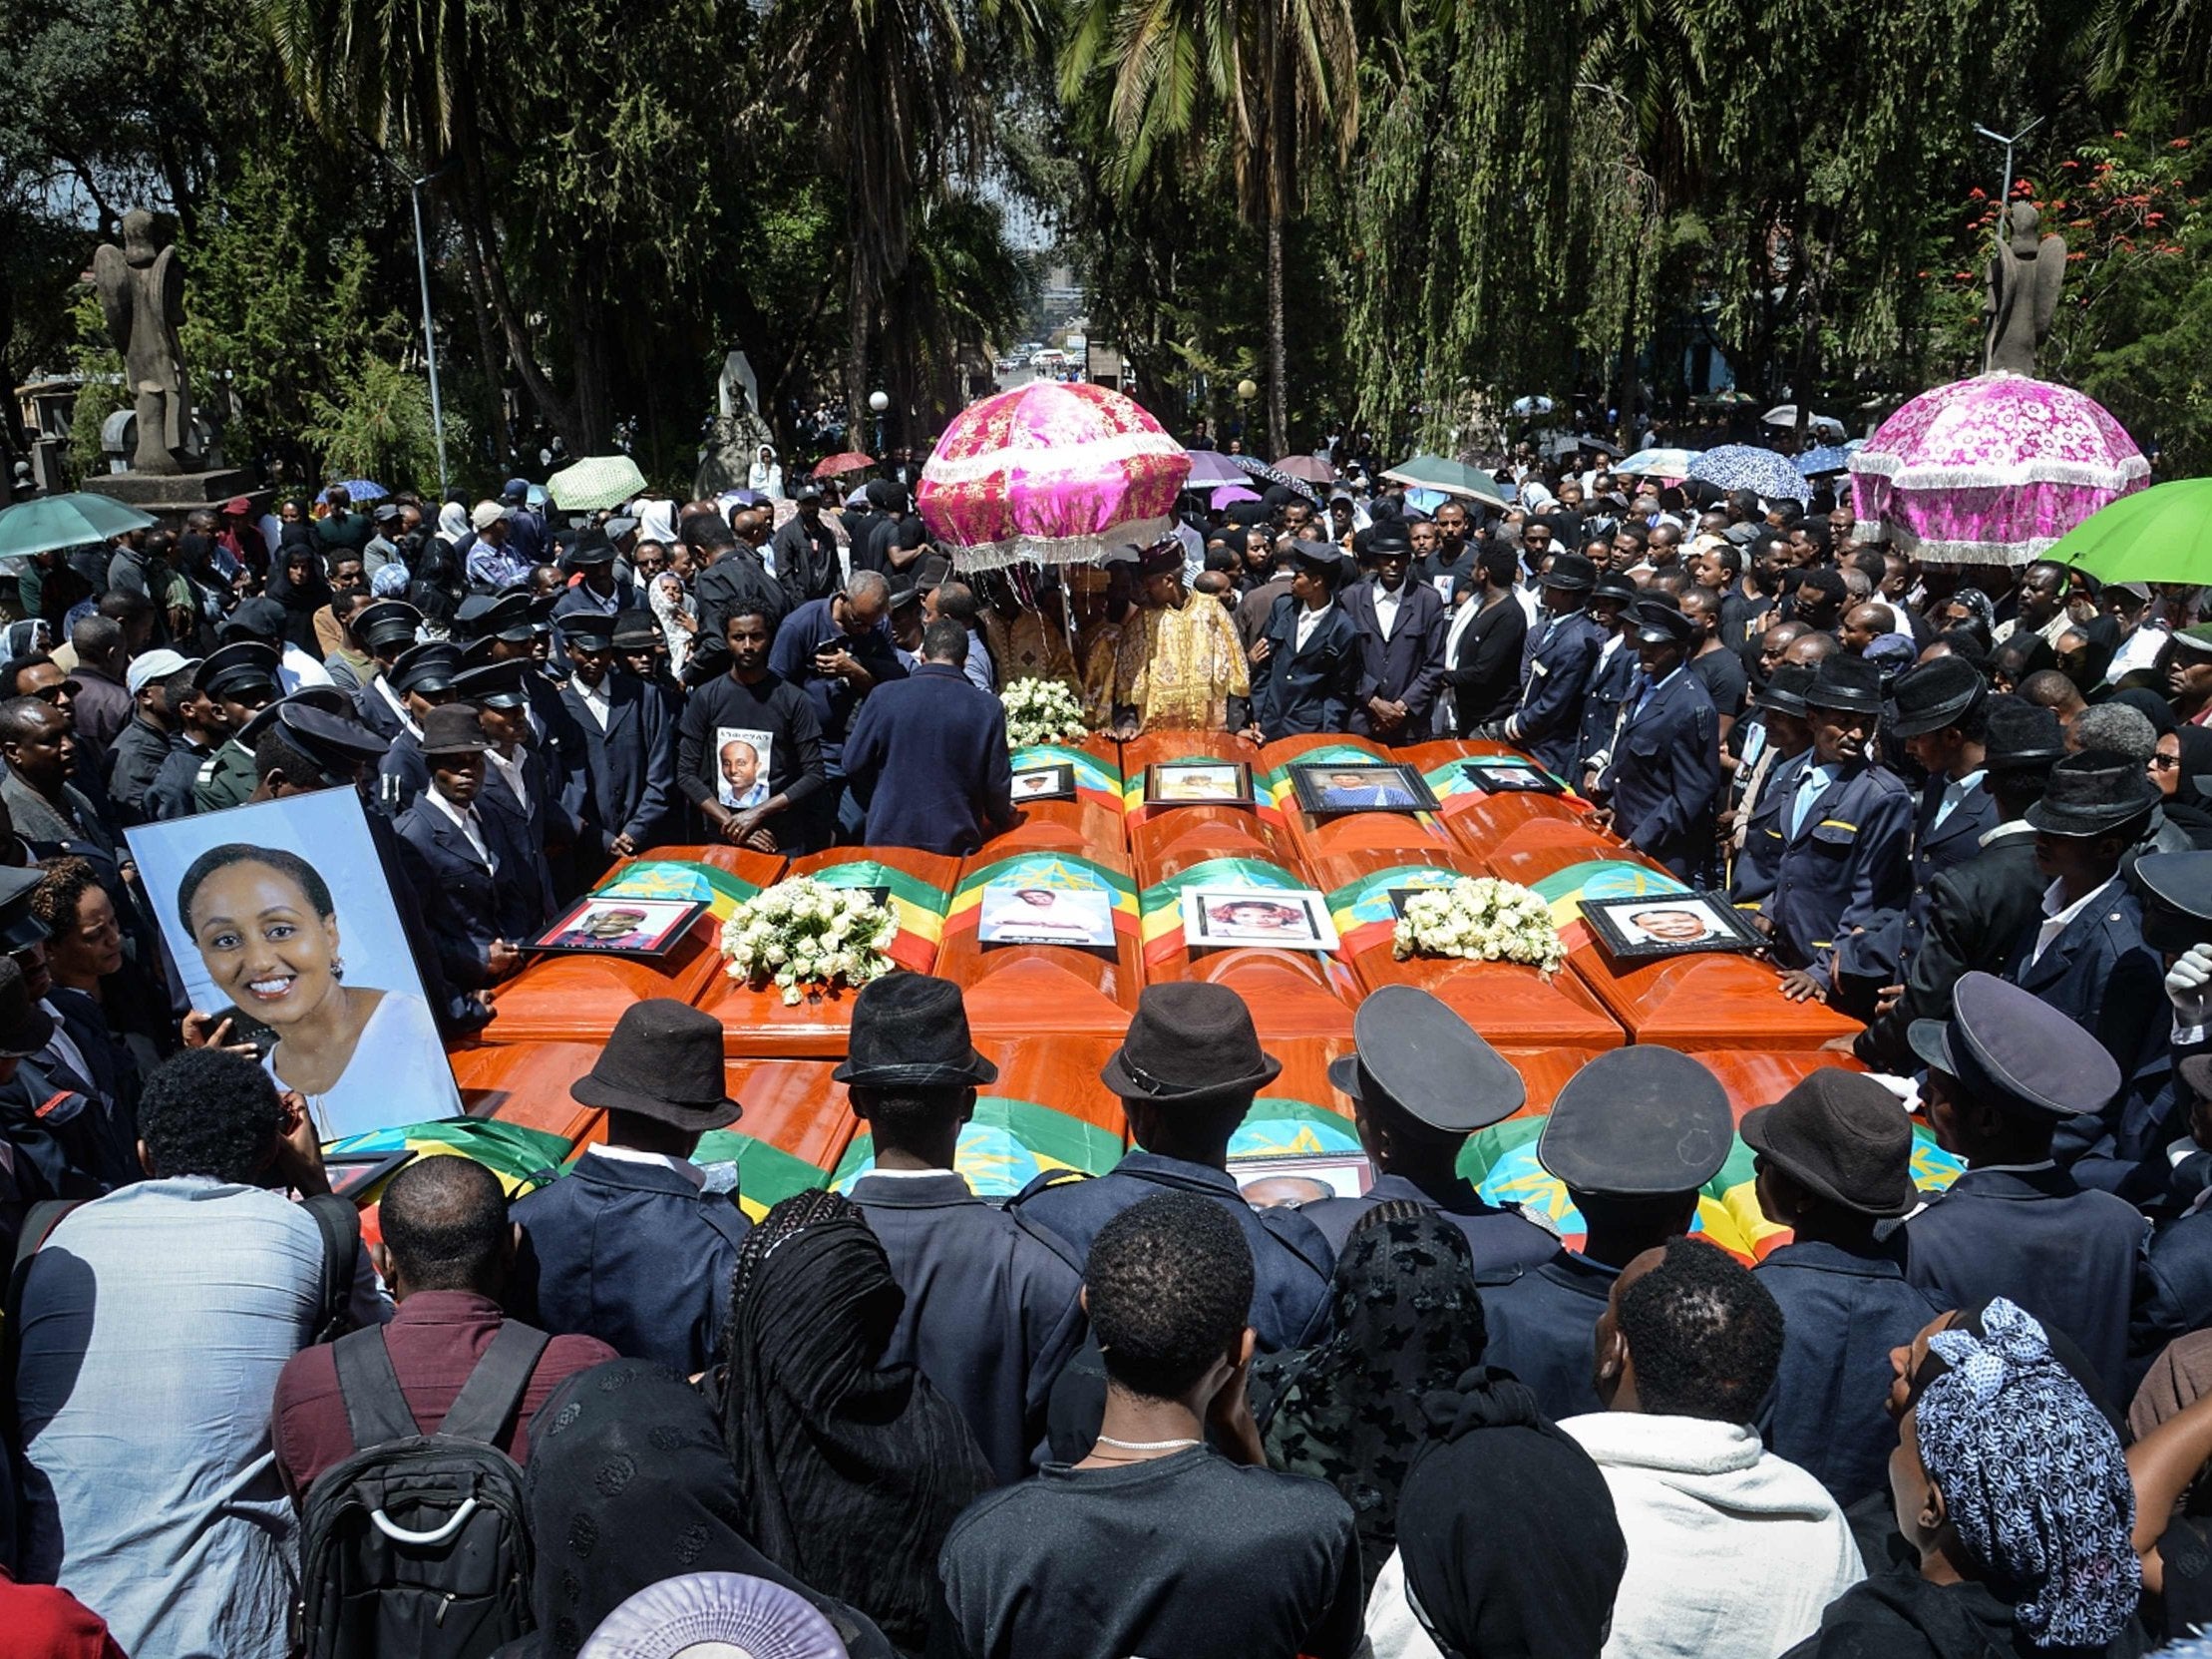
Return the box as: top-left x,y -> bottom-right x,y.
719,1190 -> 991,1650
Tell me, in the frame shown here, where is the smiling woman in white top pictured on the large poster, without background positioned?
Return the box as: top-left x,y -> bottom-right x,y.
177,841 -> 454,1141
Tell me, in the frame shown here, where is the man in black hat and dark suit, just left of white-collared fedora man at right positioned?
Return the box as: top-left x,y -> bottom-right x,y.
1851,703 -> 2066,1077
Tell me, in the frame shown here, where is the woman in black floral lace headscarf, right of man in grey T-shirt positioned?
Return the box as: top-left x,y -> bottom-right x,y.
1250,1199 -> 1484,1586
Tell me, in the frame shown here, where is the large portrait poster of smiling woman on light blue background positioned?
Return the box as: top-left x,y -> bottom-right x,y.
124,790 -> 460,1141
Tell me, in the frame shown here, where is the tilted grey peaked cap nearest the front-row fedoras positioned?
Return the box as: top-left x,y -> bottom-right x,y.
1329,985 -> 1529,1134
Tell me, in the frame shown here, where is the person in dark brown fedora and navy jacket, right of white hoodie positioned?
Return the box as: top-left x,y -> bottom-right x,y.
1741,1066 -> 1942,1508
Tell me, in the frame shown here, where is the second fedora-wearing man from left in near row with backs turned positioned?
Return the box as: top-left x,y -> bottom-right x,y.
832,974 -> 1084,1484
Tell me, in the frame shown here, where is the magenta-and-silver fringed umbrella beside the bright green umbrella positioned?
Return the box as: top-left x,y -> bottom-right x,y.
1849,372 -> 2150,564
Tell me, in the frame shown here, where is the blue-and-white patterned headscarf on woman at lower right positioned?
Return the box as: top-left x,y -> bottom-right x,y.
1914,1296 -> 2143,1648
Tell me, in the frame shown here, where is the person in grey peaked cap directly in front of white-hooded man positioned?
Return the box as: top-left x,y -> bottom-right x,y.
1478,1044 -> 1734,1421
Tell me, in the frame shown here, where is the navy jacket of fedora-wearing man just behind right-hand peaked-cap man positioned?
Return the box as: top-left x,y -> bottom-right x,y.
2005,880 -> 2185,1199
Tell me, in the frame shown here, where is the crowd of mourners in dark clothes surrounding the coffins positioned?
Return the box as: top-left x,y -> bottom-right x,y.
0,444 -> 2212,1659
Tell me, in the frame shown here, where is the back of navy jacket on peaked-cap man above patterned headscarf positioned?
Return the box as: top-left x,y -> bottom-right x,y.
1902,1168 -> 2148,1398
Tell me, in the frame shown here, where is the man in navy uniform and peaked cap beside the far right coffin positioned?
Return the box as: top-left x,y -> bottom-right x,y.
1597,600 -> 1721,880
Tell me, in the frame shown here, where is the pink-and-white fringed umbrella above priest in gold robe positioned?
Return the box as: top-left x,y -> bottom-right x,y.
914,380 -> 1190,571
